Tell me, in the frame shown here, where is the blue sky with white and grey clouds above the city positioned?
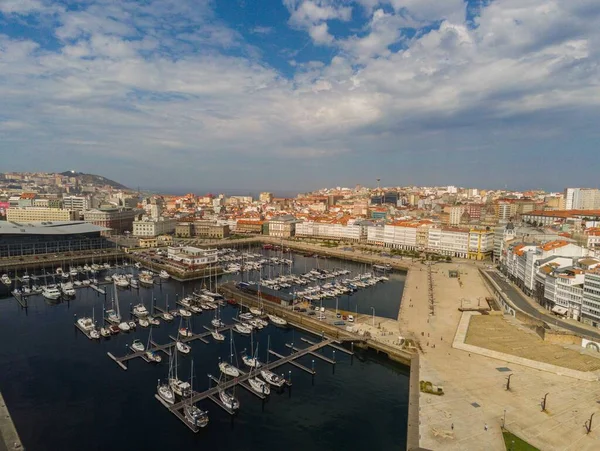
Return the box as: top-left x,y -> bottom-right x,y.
0,0 -> 600,192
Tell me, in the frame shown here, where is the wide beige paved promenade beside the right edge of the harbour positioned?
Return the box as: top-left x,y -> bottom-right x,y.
399,263 -> 600,451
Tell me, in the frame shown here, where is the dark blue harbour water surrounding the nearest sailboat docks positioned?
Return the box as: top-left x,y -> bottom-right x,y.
0,256 -> 408,451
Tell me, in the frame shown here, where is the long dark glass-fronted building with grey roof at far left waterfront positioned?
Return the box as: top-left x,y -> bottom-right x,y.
0,221 -> 114,257
